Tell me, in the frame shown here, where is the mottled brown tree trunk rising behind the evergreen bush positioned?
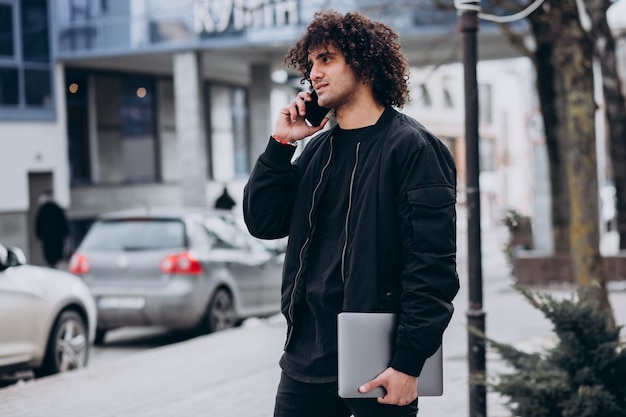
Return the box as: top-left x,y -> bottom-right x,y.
549,0 -> 610,318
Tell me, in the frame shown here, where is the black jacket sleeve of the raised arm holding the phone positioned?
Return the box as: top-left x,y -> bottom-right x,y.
243,138 -> 297,239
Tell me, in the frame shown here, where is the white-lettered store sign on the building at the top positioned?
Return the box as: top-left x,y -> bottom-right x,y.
193,0 -> 298,36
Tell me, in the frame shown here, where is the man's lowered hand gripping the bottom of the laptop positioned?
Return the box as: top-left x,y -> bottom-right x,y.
359,368 -> 417,406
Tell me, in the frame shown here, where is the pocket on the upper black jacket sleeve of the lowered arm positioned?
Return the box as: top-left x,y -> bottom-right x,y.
408,184 -> 456,254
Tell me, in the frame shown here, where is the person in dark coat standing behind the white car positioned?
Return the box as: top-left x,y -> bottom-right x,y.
35,191 -> 69,268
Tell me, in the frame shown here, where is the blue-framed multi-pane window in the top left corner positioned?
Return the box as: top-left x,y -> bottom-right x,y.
0,0 -> 53,115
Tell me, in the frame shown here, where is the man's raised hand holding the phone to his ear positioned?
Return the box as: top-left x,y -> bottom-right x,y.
274,91 -> 328,142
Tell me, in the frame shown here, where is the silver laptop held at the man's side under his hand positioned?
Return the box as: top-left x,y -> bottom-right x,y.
337,312 -> 443,398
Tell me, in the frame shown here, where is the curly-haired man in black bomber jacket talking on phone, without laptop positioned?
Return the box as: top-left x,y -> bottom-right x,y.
243,11 -> 459,417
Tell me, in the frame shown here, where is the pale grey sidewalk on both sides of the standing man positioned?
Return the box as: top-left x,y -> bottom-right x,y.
0,227 -> 626,417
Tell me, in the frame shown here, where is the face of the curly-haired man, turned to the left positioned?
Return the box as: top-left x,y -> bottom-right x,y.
309,44 -> 360,109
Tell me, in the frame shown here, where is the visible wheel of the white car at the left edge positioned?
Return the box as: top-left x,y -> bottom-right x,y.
35,311 -> 89,377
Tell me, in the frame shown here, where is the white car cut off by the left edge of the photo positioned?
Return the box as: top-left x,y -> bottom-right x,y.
0,244 -> 97,377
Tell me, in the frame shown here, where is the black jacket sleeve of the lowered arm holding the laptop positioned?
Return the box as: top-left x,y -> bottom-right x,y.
390,138 -> 459,376
